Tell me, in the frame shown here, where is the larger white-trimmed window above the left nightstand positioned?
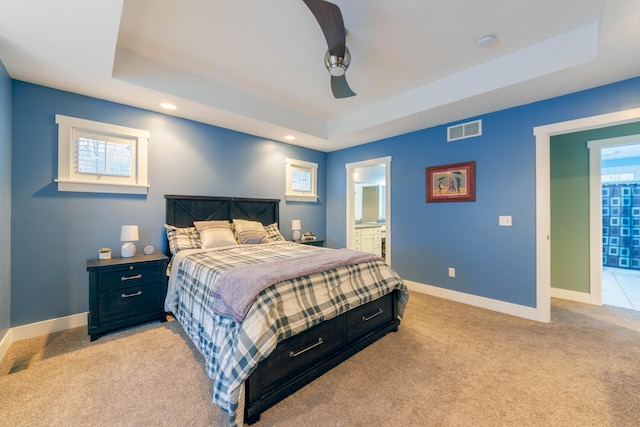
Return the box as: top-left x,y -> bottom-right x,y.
56,114 -> 149,194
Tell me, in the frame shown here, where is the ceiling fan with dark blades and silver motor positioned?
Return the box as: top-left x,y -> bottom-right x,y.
303,0 -> 355,98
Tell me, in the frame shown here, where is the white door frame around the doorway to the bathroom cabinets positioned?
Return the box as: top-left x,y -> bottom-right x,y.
345,156 -> 391,265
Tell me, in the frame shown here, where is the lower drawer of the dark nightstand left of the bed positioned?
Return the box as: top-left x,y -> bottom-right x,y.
98,283 -> 164,324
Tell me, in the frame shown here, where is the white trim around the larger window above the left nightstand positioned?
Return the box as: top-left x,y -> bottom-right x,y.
55,114 -> 149,194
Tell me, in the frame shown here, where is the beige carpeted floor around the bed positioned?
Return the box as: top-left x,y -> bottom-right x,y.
0,293 -> 640,427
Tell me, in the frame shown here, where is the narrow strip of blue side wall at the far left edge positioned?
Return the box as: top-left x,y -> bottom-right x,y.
0,61 -> 11,342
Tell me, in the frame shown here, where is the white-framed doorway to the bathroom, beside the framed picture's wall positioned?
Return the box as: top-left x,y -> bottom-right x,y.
346,157 -> 391,264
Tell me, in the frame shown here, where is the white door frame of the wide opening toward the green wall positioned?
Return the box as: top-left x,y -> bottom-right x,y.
533,108 -> 640,322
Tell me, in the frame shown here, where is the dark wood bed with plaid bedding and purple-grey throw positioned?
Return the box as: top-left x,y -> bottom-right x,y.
165,195 -> 408,426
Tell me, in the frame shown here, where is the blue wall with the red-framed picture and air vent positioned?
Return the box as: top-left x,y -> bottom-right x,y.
327,78 -> 640,307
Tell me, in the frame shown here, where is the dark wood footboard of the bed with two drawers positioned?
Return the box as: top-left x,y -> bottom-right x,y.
244,291 -> 400,424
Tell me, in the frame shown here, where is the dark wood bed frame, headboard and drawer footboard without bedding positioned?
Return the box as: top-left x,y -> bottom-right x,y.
165,195 -> 400,424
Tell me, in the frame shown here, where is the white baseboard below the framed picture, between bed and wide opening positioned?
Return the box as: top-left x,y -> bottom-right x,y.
404,280 -> 546,322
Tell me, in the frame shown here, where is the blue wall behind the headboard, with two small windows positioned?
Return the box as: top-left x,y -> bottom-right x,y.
10,81 -> 326,327
